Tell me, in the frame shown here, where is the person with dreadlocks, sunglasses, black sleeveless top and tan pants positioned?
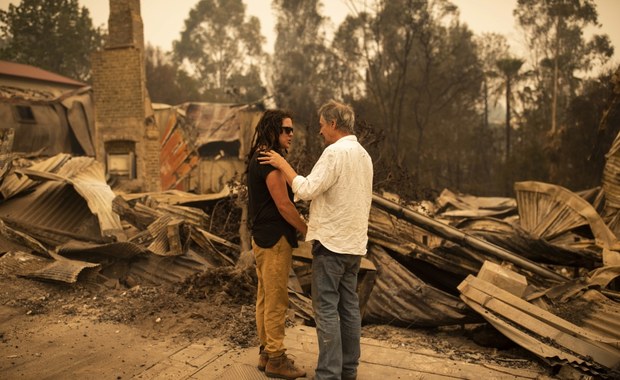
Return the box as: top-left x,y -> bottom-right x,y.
247,110 -> 308,379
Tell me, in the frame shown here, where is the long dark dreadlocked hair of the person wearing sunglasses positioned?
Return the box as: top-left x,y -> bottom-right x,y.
246,109 -> 292,168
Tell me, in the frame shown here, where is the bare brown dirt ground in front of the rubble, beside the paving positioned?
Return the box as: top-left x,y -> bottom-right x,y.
0,268 -> 551,379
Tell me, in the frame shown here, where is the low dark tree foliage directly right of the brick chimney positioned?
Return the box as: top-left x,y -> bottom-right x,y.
144,44 -> 202,105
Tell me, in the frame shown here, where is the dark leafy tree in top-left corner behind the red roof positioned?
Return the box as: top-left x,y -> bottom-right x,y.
0,0 -> 104,81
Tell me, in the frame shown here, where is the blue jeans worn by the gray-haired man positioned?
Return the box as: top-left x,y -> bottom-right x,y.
312,241 -> 362,380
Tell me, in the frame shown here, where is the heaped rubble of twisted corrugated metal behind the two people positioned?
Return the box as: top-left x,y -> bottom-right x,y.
0,72 -> 620,378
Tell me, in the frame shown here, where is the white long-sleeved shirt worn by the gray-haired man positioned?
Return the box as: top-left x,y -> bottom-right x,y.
292,135 -> 373,255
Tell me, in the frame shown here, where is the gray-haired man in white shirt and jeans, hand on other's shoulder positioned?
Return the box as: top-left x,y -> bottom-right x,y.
259,100 -> 373,380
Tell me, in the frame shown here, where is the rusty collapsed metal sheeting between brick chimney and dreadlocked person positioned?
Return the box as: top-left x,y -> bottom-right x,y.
154,103 -> 262,193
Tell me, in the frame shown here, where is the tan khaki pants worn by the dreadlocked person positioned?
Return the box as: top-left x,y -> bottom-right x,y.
252,236 -> 293,357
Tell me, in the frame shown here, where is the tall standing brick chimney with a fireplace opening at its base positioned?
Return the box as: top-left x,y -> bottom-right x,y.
92,0 -> 161,191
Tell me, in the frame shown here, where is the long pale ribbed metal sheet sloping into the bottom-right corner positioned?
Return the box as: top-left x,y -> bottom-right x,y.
459,276 -> 620,378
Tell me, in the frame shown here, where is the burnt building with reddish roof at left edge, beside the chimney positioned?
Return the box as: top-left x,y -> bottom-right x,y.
0,61 -> 95,157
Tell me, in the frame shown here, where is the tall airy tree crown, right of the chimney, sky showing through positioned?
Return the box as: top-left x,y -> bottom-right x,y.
173,0 -> 265,102
